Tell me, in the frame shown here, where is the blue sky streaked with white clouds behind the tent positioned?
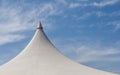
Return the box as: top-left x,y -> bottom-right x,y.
0,0 -> 120,73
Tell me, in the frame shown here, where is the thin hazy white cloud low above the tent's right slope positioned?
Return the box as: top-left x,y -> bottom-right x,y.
59,44 -> 120,63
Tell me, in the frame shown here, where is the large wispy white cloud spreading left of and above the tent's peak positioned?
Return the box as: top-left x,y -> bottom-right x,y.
0,1 -> 61,45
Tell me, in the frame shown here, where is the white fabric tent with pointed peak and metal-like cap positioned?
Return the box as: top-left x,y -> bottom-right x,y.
0,23 -> 117,75
